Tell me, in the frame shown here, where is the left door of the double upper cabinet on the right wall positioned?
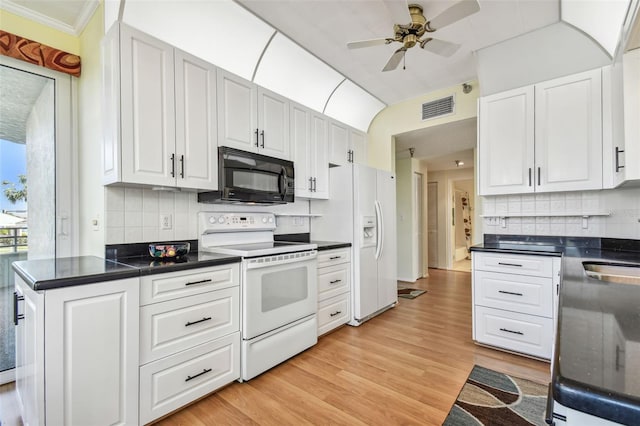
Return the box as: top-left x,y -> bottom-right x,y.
478,86 -> 534,195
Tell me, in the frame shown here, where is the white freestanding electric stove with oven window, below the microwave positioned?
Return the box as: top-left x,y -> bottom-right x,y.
198,212 -> 318,380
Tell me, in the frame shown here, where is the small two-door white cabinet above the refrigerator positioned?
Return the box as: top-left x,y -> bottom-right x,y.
329,119 -> 368,166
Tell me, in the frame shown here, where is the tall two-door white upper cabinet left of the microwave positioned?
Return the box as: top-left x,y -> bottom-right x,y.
103,24 -> 217,189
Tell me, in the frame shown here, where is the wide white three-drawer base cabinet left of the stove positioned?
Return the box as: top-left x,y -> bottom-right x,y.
140,263 -> 240,424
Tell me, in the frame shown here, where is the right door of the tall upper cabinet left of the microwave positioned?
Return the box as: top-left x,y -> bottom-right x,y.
175,50 -> 218,189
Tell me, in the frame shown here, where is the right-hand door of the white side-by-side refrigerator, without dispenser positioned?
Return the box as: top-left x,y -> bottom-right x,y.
376,170 -> 398,309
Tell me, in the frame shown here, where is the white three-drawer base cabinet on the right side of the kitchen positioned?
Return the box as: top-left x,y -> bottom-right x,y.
472,251 -> 560,359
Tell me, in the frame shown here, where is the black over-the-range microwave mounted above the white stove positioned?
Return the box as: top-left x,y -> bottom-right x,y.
198,146 -> 295,204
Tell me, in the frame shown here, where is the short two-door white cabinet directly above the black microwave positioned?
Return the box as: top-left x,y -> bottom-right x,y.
218,71 -> 290,160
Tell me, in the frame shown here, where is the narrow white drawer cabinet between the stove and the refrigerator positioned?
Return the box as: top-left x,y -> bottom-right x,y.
318,247 -> 351,336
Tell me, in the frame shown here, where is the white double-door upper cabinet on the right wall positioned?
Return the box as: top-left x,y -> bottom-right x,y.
478,69 -> 602,195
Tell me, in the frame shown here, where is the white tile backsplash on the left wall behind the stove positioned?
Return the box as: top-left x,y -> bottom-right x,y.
105,186 -> 310,244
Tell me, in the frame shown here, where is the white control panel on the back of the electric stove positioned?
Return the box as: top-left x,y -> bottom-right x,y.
198,212 -> 276,233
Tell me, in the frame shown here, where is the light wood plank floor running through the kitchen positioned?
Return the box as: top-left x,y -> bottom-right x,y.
0,269 -> 549,426
